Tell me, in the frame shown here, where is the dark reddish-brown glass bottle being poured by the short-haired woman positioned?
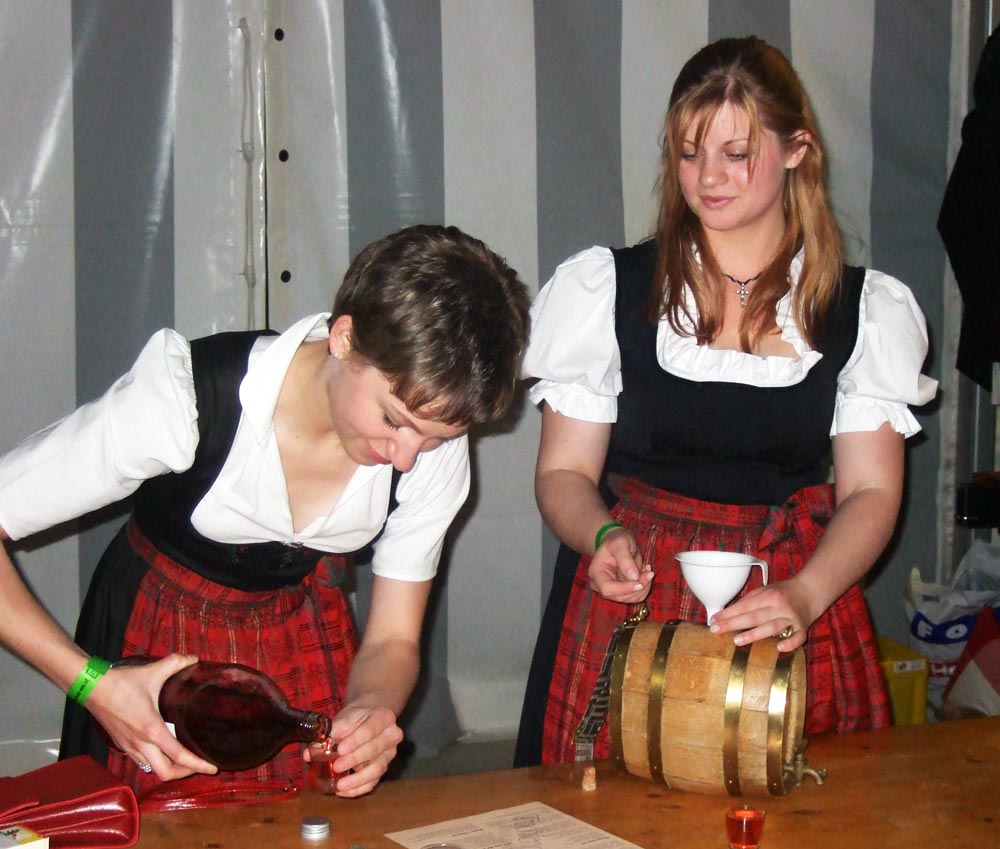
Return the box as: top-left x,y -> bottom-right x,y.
116,658 -> 330,771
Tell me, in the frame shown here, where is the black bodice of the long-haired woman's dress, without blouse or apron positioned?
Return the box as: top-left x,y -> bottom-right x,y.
606,241 -> 864,504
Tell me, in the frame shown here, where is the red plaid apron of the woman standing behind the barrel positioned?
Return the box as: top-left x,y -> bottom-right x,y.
542,480 -> 889,763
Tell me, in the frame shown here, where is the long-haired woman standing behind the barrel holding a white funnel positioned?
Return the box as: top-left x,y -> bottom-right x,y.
517,37 -> 935,764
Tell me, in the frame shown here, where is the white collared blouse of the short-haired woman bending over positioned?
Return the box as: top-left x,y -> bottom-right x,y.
0,313 -> 471,581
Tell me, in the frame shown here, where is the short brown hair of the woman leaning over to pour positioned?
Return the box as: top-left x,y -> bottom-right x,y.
330,224 -> 529,425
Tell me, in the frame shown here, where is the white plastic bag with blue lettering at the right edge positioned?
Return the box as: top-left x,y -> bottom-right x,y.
903,540 -> 1000,706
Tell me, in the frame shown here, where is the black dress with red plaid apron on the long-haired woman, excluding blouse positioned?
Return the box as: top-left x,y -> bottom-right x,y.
514,241 -> 889,766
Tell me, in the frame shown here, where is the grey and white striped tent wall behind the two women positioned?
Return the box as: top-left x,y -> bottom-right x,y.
0,0 -> 964,757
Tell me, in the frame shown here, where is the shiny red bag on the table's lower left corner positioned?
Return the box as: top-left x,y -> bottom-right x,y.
0,755 -> 139,849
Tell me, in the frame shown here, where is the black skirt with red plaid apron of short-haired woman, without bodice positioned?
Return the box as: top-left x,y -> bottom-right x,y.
60,520 -> 357,793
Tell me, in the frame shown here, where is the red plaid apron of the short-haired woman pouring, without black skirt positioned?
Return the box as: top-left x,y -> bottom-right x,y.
108,523 -> 357,792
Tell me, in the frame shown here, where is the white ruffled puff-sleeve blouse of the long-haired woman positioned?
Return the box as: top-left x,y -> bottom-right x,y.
523,247 -> 937,436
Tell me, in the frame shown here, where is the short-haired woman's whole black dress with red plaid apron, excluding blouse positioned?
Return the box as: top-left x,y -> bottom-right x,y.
59,331 -> 364,792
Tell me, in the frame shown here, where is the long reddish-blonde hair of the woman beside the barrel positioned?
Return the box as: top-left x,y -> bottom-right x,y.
646,36 -> 843,352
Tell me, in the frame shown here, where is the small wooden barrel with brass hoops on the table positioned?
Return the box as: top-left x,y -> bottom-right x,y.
608,621 -> 806,796
